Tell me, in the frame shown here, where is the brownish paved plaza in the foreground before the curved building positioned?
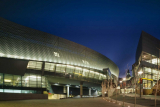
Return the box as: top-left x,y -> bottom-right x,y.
0,97 -> 121,107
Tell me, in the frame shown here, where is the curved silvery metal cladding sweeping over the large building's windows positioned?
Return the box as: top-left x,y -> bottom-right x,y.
0,18 -> 119,77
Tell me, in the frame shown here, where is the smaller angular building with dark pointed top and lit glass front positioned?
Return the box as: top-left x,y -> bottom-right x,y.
132,31 -> 160,89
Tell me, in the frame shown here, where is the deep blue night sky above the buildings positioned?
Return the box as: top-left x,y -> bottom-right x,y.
0,0 -> 160,77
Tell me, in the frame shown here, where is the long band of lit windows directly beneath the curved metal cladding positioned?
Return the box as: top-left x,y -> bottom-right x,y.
27,61 -> 106,80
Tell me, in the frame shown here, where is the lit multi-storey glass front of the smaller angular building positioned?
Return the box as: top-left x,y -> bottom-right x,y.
134,51 -> 160,89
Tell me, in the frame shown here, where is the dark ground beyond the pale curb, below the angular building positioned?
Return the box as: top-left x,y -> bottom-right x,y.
111,94 -> 160,107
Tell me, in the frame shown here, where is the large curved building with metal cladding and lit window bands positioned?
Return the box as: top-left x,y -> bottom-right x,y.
0,18 -> 119,97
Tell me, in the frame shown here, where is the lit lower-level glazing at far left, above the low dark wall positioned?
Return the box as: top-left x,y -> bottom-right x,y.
0,73 -> 48,93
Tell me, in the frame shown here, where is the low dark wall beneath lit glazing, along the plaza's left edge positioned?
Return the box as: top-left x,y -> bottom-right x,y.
0,93 -> 48,101
